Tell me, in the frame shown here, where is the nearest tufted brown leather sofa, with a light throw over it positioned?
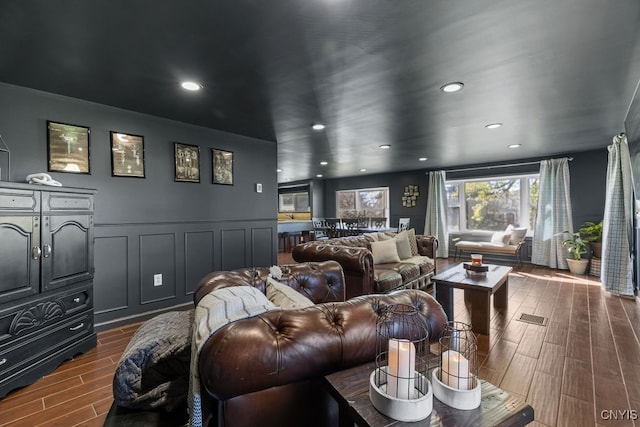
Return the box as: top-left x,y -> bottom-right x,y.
194,261 -> 446,427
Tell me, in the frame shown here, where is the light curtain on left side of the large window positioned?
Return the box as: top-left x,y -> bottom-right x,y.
424,171 -> 449,258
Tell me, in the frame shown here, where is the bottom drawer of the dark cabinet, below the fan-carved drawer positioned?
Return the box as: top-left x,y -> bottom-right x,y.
0,310 -> 93,385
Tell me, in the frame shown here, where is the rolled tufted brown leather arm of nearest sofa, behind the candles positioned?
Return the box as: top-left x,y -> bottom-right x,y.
198,289 -> 447,400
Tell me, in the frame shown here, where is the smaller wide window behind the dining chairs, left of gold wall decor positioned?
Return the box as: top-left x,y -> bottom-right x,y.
336,187 -> 389,219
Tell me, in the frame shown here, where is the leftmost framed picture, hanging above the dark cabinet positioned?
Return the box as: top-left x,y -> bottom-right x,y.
47,120 -> 91,174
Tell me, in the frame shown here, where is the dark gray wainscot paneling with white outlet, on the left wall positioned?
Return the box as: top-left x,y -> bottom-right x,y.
94,219 -> 277,328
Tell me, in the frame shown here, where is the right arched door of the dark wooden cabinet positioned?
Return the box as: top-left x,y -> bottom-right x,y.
42,215 -> 93,290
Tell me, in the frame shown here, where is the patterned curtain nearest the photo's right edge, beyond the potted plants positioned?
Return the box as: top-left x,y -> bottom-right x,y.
600,134 -> 633,296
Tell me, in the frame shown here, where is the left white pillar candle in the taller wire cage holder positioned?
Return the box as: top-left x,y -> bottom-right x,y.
387,338 -> 416,399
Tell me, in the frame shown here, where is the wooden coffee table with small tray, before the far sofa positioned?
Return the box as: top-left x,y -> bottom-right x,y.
431,263 -> 513,335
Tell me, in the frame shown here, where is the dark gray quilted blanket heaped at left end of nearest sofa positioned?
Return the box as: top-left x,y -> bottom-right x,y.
113,309 -> 194,412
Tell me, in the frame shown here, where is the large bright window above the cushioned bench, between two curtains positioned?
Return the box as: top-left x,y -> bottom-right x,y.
445,174 -> 539,232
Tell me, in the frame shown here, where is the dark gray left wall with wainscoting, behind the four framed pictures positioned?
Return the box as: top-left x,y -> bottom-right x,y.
0,83 -> 277,324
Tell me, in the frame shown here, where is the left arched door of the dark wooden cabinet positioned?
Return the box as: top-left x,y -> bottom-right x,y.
0,216 -> 40,303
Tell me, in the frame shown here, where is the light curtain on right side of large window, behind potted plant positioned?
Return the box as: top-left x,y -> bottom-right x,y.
531,157 -> 573,270
